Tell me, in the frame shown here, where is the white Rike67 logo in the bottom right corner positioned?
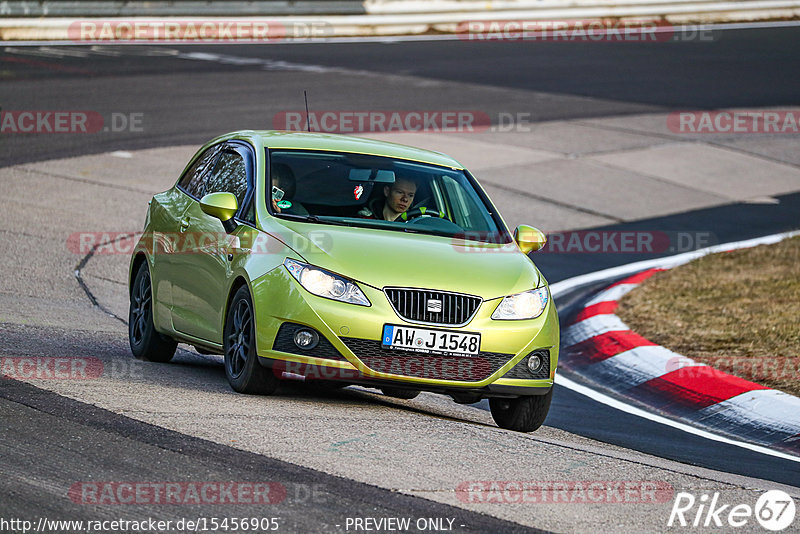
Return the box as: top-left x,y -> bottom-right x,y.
667,490 -> 796,532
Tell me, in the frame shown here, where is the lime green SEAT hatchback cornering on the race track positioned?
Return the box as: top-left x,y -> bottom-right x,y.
129,131 -> 559,432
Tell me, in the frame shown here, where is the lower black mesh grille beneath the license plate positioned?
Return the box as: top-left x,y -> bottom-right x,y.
342,337 -> 514,382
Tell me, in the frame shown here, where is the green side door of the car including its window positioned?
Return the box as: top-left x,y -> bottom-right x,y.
172,142 -> 254,343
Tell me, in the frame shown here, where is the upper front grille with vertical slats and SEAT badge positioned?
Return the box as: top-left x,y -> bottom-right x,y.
383,287 -> 481,326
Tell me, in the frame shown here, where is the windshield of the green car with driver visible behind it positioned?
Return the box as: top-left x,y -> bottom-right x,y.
265,149 -> 511,243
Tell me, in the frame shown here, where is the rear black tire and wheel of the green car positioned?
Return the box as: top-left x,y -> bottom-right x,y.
128,262 -> 178,363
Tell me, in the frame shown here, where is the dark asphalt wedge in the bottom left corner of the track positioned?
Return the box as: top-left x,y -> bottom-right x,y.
0,378 -> 536,532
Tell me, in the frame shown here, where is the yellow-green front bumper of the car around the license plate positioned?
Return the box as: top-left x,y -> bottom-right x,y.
251,267 -> 559,397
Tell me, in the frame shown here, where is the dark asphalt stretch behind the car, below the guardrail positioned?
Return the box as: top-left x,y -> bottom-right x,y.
0,27 -> 800,165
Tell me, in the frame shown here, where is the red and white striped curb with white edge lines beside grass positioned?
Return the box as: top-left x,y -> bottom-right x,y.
551,232 -> 800,461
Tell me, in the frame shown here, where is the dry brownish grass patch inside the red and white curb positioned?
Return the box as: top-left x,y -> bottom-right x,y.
616,237 -> 800,396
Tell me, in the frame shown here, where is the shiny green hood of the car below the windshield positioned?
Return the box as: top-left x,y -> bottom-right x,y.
271,220 -> 541,300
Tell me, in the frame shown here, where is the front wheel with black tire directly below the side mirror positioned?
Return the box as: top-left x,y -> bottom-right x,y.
223,286 -> 279,395
